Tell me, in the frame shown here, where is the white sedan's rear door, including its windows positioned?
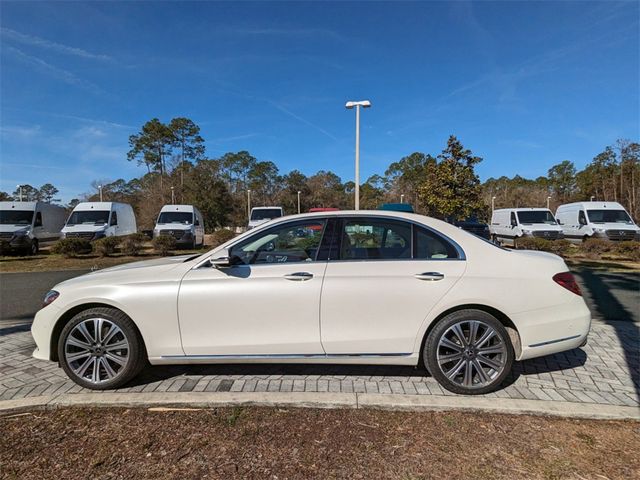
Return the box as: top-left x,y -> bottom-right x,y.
320,216 -> 466,355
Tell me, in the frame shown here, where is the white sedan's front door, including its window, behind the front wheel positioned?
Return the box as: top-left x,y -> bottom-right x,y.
178,218 -> 327,356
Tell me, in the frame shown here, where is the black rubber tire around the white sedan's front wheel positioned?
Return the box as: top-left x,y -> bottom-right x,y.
58,307 -> 147,390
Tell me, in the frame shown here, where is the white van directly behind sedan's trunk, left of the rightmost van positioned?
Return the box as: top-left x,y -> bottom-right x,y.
489,208 -> 562,247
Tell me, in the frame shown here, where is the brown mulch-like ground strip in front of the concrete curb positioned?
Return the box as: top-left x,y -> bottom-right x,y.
0,408 -> 640,479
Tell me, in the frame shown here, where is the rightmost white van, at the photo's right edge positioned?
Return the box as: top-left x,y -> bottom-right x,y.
556,202 -> 640,241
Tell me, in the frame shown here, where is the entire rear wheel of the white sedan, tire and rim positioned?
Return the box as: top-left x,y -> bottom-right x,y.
423,310 -> 515,395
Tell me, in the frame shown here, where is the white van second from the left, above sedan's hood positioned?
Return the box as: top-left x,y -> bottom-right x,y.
62,202 -> 137,240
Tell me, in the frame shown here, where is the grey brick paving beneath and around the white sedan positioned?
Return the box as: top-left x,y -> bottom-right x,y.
0,322 -> 640,408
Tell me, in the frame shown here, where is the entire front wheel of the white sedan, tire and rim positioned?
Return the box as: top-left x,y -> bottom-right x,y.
58,308 -> 146,390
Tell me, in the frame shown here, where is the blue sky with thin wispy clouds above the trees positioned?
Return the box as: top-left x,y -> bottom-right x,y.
0,1 -> 640,201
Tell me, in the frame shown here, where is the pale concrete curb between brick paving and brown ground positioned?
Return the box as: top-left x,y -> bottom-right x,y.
0,392 -> 640,421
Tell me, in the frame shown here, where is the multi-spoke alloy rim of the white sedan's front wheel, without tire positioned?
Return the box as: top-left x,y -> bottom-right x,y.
64,318 -> 130,384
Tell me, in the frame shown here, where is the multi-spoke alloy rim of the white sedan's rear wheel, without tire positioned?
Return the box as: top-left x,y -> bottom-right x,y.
436,320 -> 507,389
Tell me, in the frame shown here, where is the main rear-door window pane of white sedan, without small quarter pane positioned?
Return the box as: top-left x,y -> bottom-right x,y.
340,218 -> 411,260
